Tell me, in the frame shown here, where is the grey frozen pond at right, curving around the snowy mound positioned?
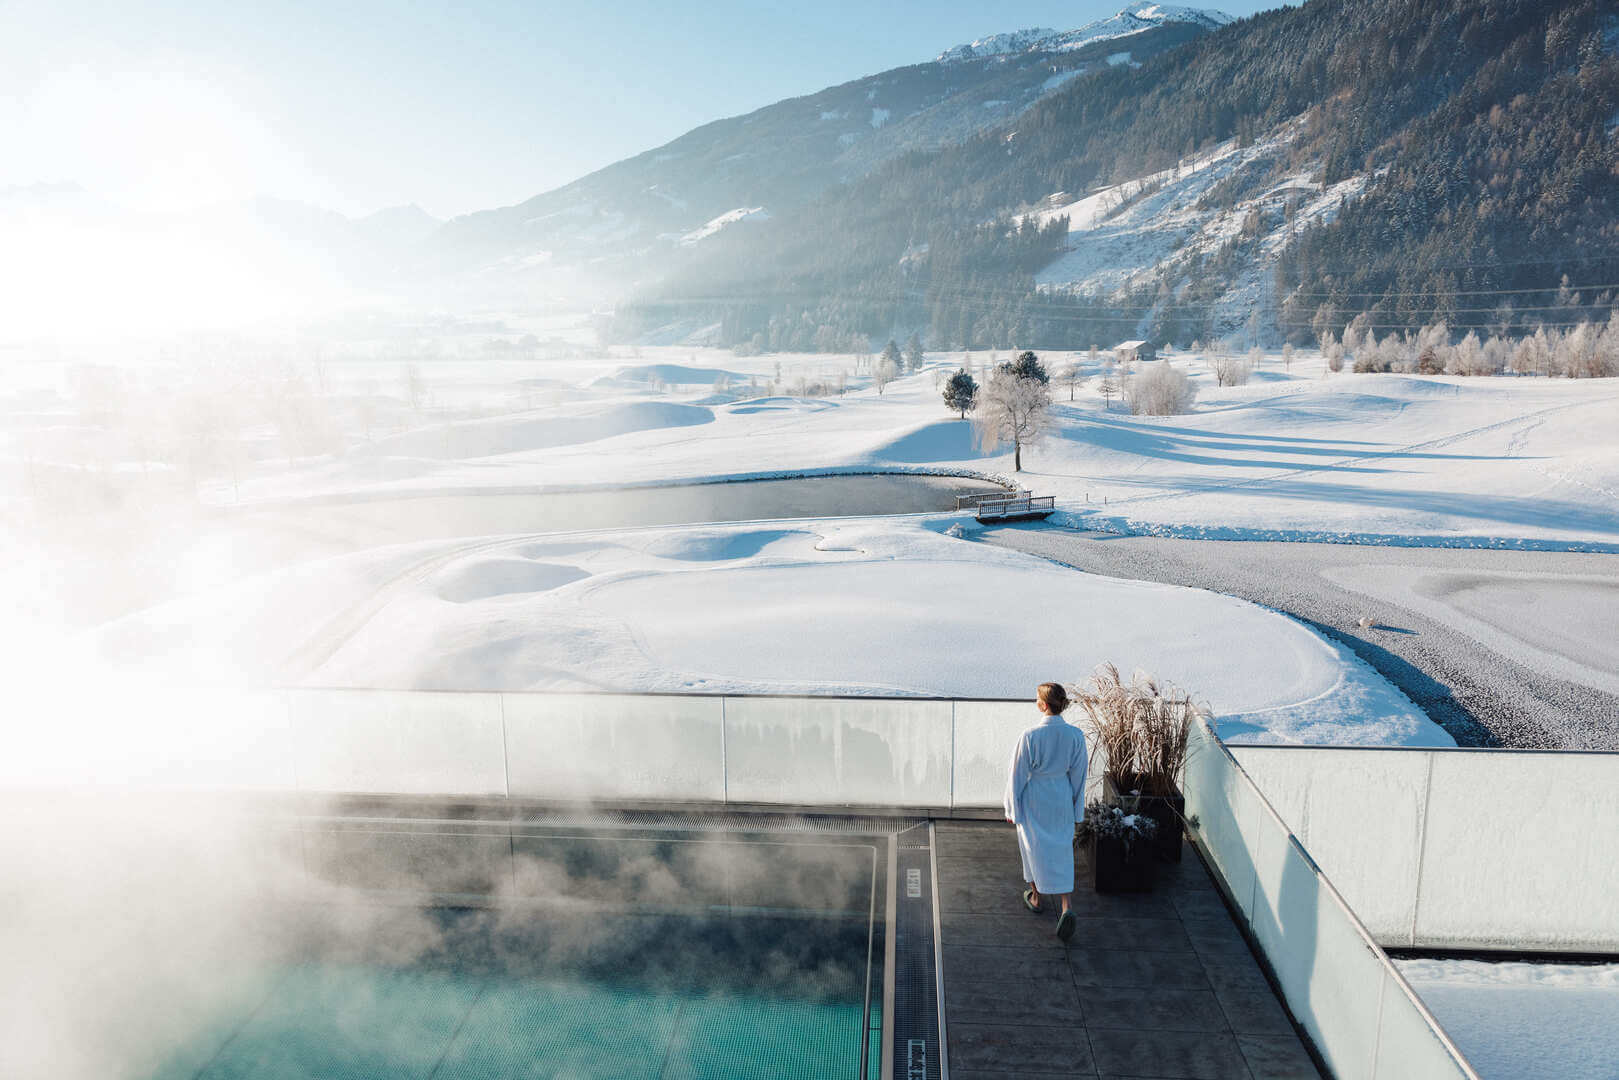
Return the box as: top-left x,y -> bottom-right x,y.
981,523 -> 1619,750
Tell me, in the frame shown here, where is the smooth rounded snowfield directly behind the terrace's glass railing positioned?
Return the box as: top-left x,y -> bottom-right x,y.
91,515 -> 1452,745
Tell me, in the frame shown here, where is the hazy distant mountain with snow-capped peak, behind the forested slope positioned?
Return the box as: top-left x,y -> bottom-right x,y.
427,3 -> 1226,296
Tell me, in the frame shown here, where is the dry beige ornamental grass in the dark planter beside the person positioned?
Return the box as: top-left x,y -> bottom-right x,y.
1075,664 -> 1209,795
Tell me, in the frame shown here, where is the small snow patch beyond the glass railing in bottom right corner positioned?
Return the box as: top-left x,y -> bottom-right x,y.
1396,960 -> 1619,1080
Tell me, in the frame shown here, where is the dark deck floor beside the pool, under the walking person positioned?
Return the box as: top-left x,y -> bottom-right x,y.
934,821 -> 1321,1080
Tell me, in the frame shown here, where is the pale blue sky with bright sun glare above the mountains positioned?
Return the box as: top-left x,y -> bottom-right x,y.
0,0 -> 1277,217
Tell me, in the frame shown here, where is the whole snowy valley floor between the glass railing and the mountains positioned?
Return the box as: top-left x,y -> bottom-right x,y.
19,348 -> 1619,746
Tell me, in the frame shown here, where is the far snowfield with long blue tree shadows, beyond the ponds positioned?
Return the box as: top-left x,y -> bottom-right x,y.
214,348 -> 1619,549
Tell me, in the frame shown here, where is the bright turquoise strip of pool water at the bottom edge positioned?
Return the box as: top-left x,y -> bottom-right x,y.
160,965 -> 874,1080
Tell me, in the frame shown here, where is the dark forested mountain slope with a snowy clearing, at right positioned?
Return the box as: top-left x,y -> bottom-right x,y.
615,0 -> 1619,348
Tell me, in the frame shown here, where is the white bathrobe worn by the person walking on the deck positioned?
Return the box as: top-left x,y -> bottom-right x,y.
1005,716 -> 1086,895
